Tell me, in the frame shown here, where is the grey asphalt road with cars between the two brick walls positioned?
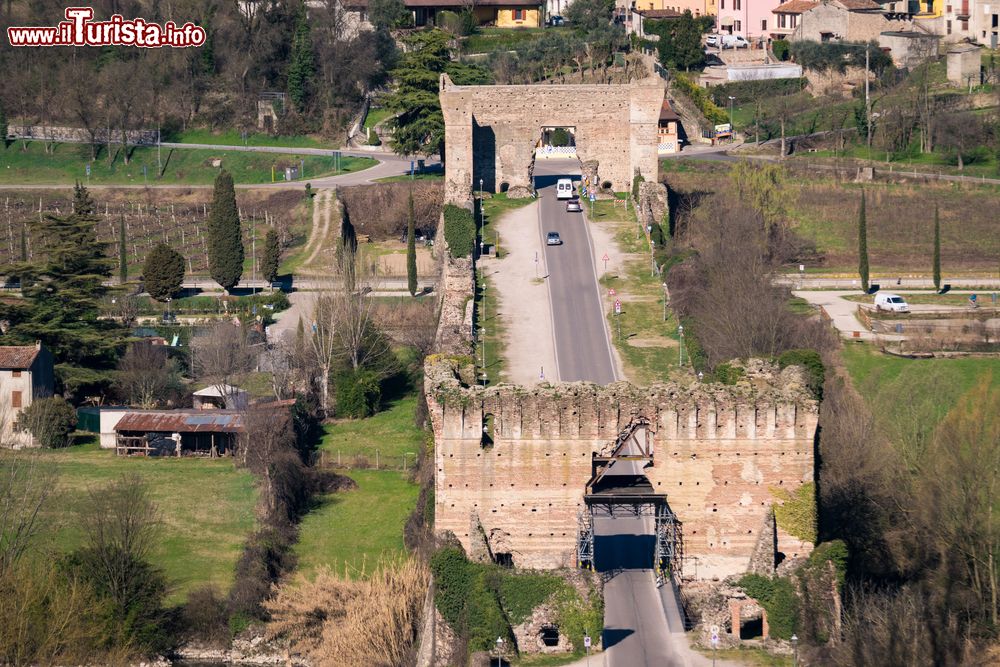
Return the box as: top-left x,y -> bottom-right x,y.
535,160 -> 618,384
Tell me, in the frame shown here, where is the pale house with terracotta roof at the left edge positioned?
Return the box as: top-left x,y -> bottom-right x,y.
0,342 -> 55,447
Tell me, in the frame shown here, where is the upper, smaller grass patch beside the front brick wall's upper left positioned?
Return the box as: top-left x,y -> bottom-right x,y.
320,395 -> 424,466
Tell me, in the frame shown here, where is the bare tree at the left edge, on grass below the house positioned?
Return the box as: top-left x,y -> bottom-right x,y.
0,449 -> 56,577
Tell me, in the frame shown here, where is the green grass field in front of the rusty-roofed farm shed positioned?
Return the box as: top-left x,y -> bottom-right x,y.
17,442 -> 257,603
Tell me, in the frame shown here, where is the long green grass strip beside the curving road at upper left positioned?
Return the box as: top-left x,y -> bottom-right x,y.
0,142 -> 376,185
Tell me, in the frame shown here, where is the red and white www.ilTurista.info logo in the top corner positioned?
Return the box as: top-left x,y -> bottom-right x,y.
7,7 -> 205,49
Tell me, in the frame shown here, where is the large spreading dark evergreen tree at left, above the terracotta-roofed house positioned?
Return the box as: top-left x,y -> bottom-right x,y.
0,183 -> 121,380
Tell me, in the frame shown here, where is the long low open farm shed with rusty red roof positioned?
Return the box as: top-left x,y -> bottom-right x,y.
115,410 -> 244,457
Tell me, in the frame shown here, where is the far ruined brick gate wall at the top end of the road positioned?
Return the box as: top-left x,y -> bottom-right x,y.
440,74 -> 664,203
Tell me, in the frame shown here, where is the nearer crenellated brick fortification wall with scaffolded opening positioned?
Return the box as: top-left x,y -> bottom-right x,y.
425,356 -> 818,578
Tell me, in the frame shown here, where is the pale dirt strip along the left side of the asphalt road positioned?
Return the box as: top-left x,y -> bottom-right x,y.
481,202 -> 559,386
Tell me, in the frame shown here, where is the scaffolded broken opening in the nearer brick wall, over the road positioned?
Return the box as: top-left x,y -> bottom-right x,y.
577,417 -> 681,574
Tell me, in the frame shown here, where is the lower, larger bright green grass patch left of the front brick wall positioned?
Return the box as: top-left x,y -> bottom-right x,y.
295,470 -> 420,576
